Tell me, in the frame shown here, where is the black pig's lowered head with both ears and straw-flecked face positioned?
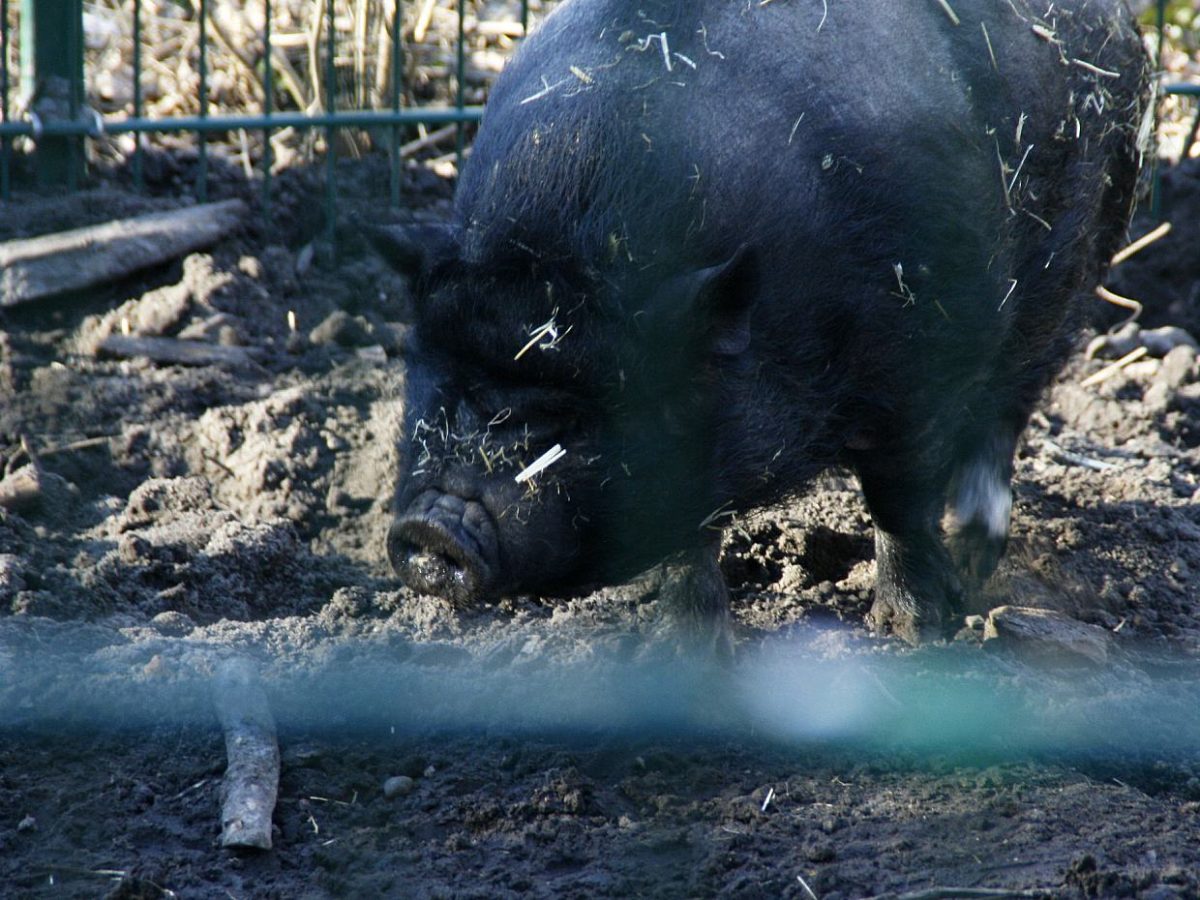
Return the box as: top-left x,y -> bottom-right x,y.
372,226 -> 751,604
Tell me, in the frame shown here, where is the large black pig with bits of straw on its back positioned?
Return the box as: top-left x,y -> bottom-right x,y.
376,0 -> 1150,642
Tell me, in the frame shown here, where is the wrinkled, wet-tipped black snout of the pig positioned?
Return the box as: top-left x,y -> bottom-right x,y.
388,491 -> 498,605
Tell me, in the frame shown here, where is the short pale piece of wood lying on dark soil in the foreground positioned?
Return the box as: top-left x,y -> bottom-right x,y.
212,659 -> 280,850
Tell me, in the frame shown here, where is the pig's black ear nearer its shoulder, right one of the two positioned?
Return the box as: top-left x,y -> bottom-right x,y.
684,244 -> 757,356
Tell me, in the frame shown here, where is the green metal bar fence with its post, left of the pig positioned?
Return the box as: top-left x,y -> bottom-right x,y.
0,0 -> 529,224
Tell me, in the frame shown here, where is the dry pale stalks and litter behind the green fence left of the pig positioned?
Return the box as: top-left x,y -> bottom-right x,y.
10,0 -> 566,175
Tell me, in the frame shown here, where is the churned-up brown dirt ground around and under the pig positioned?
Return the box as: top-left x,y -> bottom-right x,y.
0,144 -> 1200,900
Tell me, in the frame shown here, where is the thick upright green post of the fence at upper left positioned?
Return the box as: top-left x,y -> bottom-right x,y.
20,0 -> 83,188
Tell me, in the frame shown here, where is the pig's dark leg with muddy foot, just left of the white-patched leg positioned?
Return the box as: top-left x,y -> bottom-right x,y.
856,454 -> 962,644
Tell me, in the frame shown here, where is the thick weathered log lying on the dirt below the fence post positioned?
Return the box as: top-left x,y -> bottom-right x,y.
0,200 -> 246,307
